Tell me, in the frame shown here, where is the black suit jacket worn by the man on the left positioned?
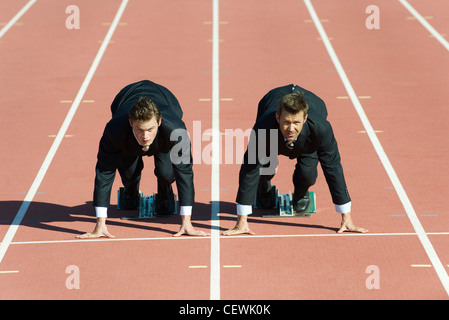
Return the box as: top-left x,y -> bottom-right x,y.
93,80 -> 194,207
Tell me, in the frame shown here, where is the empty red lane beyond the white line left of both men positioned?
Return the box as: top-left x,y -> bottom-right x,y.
0,1 -> 124,239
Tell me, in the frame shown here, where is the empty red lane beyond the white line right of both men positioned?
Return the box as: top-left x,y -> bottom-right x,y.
310,1 -> 449,296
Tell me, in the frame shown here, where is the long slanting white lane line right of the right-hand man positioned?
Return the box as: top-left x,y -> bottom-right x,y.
304,0 -> 449,295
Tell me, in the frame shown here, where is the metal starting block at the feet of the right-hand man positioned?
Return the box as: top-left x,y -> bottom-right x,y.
254,186 -> 316,217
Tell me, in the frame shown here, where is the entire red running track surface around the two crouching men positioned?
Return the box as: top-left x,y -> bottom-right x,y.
0,0 -> 449,300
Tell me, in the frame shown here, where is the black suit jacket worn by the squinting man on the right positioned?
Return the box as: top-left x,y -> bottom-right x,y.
236,85 -> 351,205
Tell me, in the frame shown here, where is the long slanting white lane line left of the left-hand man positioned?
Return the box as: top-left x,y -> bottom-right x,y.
0,0 -> 128,263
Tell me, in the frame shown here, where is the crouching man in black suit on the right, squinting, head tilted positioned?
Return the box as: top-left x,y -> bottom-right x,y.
224,85 -> 368,235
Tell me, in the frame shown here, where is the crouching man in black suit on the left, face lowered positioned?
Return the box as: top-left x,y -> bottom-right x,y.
78,80 -> 207,238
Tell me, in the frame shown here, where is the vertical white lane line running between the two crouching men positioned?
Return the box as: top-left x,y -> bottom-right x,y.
210,0 -> 220,300
